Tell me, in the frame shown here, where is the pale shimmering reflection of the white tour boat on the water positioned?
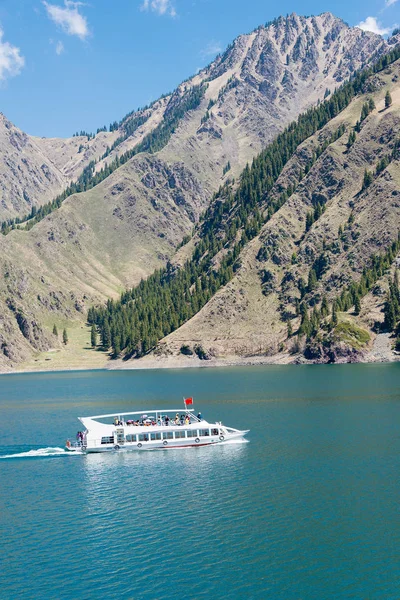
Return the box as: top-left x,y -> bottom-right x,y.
82,440 -> 248,519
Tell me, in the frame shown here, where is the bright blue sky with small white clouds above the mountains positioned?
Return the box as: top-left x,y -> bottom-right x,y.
0,0 -> 400,136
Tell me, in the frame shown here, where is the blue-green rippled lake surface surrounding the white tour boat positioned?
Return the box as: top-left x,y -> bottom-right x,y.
0,364 -> 400,600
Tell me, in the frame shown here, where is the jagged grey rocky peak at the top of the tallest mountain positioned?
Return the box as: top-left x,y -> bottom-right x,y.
208,12 -> 389,89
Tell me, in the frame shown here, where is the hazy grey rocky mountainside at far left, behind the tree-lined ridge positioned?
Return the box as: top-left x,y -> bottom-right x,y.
0,99 -> 165,223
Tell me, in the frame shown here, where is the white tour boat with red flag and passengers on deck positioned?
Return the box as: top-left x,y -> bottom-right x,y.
66,398 -> 248,453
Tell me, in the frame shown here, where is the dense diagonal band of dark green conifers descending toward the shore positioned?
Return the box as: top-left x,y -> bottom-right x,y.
88,50 -> 400,357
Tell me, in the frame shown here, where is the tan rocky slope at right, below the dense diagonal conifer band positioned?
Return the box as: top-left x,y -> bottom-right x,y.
154,62 -> 400,361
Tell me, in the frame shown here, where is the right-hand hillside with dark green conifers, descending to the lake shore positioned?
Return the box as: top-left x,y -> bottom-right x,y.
89,49 -> 400,361
